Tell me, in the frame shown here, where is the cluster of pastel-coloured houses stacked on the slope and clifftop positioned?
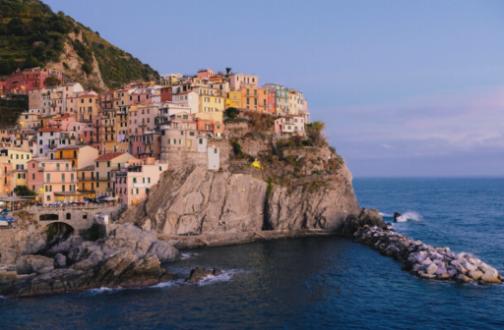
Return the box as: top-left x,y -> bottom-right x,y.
0,69 -> 309,206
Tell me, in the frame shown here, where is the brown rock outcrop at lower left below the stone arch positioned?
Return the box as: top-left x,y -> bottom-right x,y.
0,224 -> 178,296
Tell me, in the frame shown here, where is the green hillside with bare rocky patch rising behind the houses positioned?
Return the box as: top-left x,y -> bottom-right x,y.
0,0 -> 159,89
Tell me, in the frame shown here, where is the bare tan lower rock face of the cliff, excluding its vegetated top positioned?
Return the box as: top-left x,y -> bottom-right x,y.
122,156 -> 359,244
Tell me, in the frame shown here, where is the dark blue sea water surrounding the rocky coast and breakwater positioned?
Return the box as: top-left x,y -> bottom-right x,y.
0,179 -> 504,329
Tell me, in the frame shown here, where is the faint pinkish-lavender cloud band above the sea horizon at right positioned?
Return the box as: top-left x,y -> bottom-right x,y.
320,87 -> 504,157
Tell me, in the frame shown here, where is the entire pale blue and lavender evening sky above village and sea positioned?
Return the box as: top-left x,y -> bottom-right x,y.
44,0 -> 504,177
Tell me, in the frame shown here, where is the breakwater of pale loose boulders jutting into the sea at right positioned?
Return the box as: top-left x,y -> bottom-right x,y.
353,224 -> 503,284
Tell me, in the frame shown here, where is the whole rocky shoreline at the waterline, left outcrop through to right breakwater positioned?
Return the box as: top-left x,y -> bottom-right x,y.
0,209 -> 503,297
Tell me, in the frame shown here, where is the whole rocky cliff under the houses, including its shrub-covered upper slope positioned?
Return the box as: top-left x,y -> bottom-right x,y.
121,118 -> 360,247
